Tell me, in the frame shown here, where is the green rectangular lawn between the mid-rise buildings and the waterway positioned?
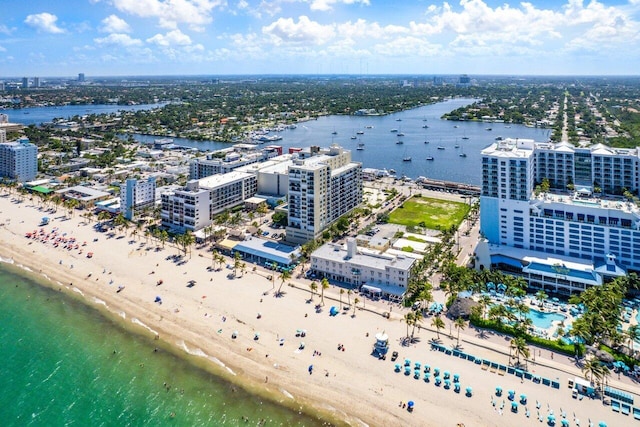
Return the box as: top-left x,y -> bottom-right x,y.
389,196 -> 470,230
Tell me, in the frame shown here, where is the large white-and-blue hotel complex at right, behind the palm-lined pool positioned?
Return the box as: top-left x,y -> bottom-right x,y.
476,139 -> 640,293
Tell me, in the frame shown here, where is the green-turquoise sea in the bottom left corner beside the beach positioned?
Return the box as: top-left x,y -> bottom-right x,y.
0,265 -> 323,427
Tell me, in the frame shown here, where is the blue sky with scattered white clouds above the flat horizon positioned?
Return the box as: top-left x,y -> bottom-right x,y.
0,0 -> 640,78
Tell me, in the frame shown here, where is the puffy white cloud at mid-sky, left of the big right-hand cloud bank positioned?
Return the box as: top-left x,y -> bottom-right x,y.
262,15 -> 335,45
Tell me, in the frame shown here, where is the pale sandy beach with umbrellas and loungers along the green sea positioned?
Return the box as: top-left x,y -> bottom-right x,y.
0,195 -> 640,427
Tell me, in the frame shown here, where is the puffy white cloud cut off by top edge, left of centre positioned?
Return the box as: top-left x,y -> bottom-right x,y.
112,0 -> 226,30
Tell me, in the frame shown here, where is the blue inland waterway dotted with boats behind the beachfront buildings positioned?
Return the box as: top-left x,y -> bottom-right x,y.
129,99 -> 549,185
